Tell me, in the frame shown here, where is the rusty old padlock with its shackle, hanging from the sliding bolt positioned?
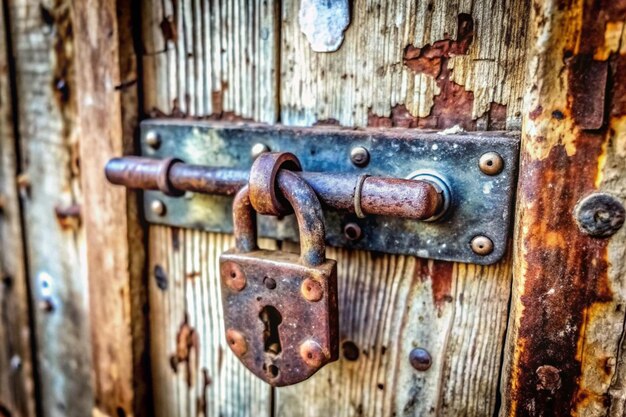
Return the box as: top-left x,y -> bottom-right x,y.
220,154 -> 339,386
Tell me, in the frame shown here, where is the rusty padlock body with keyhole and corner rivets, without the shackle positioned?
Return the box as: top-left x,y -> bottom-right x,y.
220,250 -> 339,386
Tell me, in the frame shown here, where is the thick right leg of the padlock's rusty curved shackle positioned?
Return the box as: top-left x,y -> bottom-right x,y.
276,169 -> 326,266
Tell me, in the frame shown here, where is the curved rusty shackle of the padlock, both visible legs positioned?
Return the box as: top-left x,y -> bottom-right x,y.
233,170 -> 326,266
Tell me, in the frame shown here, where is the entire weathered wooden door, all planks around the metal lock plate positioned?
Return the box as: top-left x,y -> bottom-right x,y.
0,0 -> 626,417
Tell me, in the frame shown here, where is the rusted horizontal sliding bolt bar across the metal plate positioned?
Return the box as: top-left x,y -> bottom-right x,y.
105,156 -> 445,220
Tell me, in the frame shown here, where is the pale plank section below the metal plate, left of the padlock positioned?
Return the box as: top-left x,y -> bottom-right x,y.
149,226 -> 275,417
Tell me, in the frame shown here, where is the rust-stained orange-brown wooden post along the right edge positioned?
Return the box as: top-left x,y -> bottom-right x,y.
501,0 -> 626,416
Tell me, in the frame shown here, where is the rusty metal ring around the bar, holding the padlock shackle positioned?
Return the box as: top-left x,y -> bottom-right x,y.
248,152 -> 302,216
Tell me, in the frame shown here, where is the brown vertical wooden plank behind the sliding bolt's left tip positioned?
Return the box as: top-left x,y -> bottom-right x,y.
73,0 -> 150,417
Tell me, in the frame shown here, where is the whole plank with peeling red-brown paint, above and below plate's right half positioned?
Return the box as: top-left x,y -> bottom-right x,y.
276,1 -> 528,416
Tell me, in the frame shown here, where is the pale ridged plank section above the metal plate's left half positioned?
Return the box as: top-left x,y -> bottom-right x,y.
142,0 -> 278,123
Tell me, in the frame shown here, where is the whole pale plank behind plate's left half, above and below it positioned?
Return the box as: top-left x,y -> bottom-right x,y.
142,0 -> 279,416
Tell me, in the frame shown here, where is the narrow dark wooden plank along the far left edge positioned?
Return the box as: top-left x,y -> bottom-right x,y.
0,2 -> 35,417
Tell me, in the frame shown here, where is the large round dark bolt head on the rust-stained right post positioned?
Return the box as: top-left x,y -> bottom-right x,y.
574,193 -> 626,237
